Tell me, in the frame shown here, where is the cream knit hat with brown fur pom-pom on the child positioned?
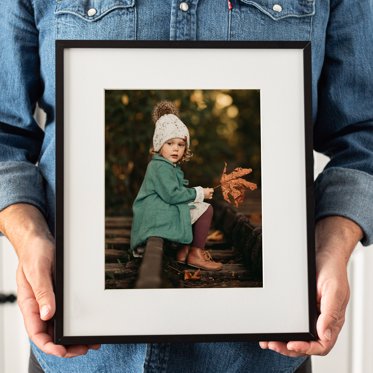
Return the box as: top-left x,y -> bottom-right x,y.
153,101 -> 190,152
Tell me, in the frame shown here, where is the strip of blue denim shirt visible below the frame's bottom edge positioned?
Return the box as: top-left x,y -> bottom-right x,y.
31,342 -> 305,373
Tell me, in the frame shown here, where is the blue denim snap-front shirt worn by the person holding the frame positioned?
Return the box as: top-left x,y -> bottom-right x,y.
0,0 -> 373,372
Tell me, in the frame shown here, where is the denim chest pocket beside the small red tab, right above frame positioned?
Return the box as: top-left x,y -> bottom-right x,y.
230,0 -> 315,40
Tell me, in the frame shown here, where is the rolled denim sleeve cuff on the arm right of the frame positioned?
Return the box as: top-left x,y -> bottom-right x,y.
315,167 -> 373,246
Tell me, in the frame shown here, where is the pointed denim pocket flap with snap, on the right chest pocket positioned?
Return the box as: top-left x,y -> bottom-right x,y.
240,0 -> 315,20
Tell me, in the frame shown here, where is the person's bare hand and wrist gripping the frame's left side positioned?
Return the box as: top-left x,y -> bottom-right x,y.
0,204 -> 99,357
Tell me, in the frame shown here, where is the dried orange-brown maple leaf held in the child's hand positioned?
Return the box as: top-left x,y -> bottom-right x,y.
220,163 -> 257,207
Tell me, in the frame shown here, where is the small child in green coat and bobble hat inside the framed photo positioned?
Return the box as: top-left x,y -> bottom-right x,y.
131,101 -> 222,271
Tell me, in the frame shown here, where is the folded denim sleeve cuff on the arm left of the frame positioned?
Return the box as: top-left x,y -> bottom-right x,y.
0,161 -> 46,216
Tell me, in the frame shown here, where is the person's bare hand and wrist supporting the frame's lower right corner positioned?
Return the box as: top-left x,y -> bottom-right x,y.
260,216 -> 363,357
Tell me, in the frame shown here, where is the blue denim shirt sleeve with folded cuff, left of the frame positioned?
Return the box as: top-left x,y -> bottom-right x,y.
0,0 -> 46,214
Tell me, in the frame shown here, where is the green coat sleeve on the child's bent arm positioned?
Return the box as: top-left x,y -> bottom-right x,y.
151,163 -> 196,205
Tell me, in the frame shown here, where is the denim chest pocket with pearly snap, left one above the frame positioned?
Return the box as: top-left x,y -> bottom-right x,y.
55,0 -> 136,40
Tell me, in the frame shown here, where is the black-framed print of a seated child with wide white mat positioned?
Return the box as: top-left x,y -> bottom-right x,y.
55,41 -> 317,344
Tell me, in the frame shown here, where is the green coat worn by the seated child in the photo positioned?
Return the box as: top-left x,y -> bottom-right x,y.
131,154 -> 196,249
